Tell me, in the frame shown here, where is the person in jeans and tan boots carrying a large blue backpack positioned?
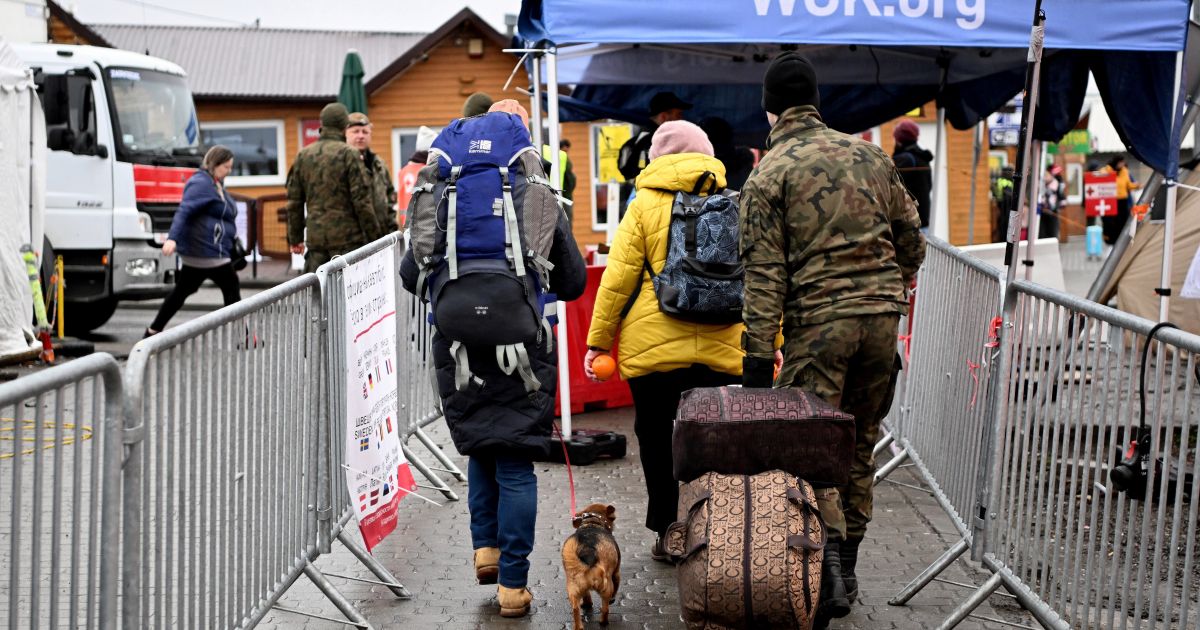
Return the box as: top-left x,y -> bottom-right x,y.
400,101 -> 587,617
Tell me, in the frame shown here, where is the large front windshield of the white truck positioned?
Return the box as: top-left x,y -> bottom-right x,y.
107,68 -> 200,155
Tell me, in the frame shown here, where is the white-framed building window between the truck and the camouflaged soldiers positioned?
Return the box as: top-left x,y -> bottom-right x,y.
200,120 -> 287,186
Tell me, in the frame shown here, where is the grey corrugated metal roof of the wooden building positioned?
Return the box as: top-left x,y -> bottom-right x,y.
90,24 -> 426,98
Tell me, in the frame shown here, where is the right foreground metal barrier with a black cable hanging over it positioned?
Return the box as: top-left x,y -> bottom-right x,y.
948,282 -> 1200,629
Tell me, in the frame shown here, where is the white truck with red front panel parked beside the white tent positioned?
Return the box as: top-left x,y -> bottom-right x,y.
13,44 -> 202,332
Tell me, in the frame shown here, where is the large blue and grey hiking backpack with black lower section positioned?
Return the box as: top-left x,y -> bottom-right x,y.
408,112 -> 562,391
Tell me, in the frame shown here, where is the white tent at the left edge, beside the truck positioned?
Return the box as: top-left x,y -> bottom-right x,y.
0,40 -> 46,355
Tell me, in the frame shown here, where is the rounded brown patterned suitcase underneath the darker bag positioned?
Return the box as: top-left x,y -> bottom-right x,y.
667,470 -> 826,630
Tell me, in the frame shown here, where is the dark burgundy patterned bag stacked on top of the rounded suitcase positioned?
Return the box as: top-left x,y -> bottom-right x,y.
672,388 -> 854,487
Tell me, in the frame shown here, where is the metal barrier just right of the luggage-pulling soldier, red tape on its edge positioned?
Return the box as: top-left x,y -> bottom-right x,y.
876,238 -> 1002,606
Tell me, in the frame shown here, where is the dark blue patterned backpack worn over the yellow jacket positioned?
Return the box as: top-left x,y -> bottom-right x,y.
624,172 -> 745,324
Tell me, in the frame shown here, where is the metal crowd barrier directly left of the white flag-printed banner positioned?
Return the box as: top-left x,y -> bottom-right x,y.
122,275 -> 379,629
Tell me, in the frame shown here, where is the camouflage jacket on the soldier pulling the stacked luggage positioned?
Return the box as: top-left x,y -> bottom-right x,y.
740,107 -> 925,359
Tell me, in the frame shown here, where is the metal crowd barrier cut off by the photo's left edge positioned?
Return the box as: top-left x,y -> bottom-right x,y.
0,354 -> 122,629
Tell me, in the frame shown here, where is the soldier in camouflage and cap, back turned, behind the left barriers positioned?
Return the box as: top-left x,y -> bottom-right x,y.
288,103 -> 385,272
